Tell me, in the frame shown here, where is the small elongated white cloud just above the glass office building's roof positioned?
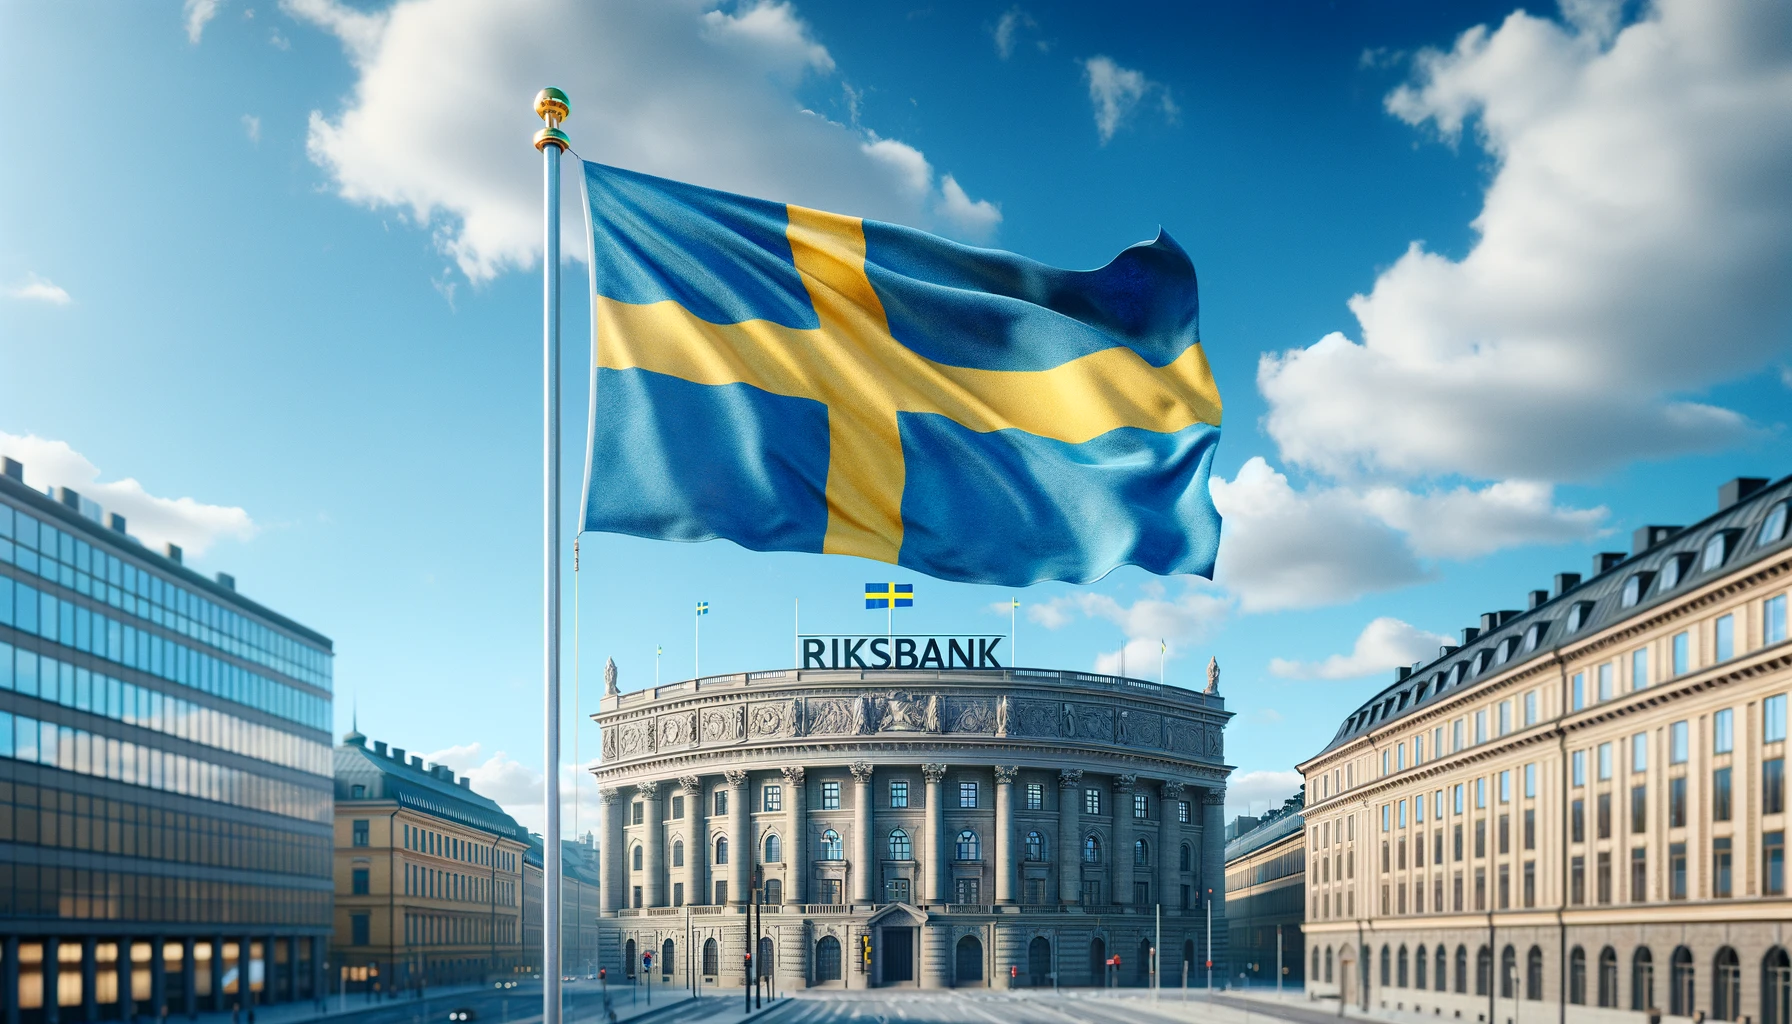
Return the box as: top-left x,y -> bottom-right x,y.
0,432 -> 256,556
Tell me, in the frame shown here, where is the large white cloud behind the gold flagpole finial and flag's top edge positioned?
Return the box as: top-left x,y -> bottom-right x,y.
283,0 -> 995,280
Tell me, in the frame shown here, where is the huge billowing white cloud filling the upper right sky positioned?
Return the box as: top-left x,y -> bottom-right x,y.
1258,0 -> 1792,481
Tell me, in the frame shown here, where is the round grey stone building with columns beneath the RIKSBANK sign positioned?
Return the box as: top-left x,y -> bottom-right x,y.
593,669 -> 1229,988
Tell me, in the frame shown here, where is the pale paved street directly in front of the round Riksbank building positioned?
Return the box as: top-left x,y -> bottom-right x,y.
765,988 -> 1337,1024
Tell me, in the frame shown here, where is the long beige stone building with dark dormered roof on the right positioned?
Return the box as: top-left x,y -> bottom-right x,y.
1301,479 -> 1792,1024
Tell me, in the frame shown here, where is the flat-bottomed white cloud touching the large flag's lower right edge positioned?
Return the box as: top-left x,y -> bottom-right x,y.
1211,457 -> 1607,612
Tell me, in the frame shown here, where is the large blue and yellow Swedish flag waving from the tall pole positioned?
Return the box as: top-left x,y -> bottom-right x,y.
584,163 -> 1220,586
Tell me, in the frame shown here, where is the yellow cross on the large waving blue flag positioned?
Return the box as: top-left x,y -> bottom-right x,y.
597,206 -> 1220,563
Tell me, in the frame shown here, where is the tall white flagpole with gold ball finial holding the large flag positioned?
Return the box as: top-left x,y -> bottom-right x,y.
534,88 -> 570,1024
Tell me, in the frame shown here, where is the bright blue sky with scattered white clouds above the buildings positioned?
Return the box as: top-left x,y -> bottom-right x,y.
0,0 -> 1792,821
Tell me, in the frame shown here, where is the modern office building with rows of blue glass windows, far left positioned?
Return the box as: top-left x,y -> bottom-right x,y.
0,459 -> 332,1024
